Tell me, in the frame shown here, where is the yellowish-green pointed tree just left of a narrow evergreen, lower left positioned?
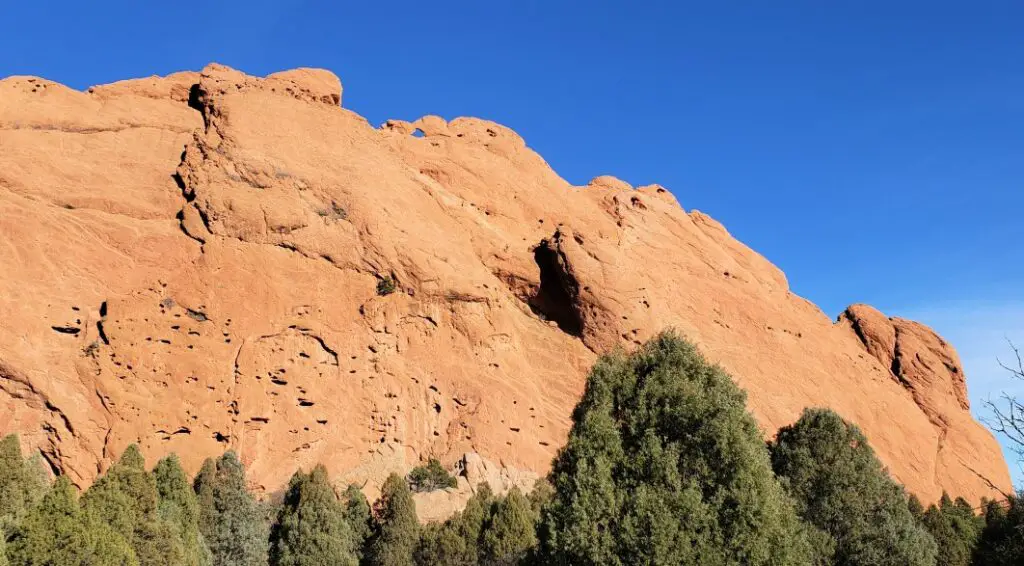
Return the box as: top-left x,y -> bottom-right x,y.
82,444 -> 184,566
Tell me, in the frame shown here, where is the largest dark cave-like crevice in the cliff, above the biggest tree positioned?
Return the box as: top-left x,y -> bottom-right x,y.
526,232 -> 584,338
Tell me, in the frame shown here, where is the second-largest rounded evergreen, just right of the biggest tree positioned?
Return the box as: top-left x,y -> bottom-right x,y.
771,409 -> 936,566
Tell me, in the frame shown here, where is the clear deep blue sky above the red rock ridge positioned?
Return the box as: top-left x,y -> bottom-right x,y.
0,0 -> 1024,481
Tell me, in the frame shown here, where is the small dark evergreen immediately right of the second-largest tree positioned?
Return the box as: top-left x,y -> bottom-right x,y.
922,493 -> 985,566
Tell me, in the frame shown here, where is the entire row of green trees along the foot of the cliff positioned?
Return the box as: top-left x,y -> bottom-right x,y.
0,333 -> 1024,566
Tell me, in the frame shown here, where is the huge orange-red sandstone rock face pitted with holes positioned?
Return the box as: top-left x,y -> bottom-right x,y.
0,64 -> 1011,499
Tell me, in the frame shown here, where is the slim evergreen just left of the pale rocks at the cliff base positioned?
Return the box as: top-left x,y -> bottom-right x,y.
368,474 -> 420,566
